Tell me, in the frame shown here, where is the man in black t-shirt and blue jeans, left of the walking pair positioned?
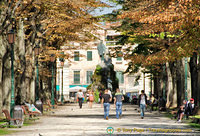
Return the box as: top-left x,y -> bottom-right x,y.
101,89 -> 111,120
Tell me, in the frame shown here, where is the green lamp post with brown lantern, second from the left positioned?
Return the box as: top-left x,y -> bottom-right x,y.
34,44 -> 40,101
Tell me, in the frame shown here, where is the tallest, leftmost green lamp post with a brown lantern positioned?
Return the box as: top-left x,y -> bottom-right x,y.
8,29 -> 15,117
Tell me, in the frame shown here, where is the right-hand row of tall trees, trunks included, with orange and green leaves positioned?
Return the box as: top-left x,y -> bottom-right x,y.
104,0 -> 200,106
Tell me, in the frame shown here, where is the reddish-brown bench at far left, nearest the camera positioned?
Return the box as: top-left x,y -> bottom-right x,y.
2,109 -> 23,127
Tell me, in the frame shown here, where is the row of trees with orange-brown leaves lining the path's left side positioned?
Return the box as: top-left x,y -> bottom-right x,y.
0,0 -> 105,112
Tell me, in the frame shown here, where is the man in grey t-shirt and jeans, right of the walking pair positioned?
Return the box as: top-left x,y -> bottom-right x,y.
114,88 -> 124,119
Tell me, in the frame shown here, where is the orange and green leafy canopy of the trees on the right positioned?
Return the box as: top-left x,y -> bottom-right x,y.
104,0 -> 200,104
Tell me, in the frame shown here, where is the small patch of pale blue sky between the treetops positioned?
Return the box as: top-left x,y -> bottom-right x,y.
92,0 -> 121,16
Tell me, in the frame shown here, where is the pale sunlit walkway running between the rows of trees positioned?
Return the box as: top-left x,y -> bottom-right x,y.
5,104 -> 200,136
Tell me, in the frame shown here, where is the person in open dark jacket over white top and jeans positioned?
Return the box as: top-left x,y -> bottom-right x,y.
138,90 -> 147,119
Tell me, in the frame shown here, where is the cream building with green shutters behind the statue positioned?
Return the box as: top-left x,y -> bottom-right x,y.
56,22 -> 151,101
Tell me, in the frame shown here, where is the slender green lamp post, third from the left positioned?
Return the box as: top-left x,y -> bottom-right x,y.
50,54 -> 55,107
